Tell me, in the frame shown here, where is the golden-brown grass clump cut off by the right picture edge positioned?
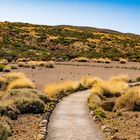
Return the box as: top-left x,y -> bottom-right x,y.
116,86 -> 140,111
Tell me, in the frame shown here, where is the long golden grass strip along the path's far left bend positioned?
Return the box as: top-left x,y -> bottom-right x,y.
43,77 -> 104,98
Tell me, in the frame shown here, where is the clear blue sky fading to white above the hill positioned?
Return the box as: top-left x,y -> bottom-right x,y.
0,0 -> 140,34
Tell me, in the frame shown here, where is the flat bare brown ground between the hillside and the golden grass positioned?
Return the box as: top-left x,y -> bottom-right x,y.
9,62 -> 140,90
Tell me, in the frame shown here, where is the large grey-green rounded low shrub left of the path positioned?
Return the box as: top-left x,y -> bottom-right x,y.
0,89 -> 51,119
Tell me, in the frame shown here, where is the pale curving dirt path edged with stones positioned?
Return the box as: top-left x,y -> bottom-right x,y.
47,91 -> 103,140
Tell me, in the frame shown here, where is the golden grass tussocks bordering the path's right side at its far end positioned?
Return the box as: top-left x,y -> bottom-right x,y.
88,75 -> 129,120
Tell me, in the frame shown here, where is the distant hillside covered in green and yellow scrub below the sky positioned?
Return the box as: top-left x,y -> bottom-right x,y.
0,22 -> 140,61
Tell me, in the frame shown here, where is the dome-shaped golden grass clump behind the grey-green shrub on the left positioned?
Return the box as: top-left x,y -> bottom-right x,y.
7,78 -> 35,90
